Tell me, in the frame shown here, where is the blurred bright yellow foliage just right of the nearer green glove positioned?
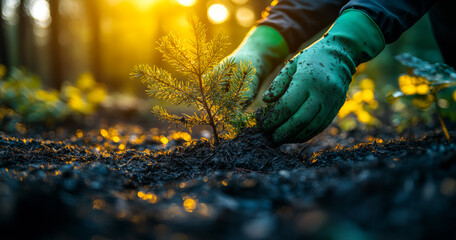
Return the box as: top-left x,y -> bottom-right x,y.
336,64 -> 380,131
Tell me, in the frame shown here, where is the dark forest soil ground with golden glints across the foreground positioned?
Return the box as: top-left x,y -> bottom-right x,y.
0,120 -> 456,239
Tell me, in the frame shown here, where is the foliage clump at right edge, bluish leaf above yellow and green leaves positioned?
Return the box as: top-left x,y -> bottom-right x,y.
387,53 -> 456,139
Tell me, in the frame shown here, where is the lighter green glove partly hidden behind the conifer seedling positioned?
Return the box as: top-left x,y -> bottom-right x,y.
227,25 -> 289,101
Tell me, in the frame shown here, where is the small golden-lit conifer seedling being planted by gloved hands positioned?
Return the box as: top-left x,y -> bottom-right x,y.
130,17 -> 255,144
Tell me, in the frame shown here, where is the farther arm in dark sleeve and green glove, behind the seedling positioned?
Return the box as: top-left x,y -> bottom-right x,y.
228,0 -> 347,102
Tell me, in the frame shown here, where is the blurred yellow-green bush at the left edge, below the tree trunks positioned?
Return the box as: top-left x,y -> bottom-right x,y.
0,66 -> 106,134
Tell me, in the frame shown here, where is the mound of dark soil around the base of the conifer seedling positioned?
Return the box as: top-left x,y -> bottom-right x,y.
144,128 -> 304,184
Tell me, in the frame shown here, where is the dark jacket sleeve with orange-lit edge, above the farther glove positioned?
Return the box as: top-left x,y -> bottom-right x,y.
257,0 -> 348,52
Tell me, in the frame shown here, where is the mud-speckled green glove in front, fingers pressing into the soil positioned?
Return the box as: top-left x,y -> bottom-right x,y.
261,9 -> 385,143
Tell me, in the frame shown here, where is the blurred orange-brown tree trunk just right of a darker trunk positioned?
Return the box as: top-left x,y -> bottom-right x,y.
85,0 -> 103,82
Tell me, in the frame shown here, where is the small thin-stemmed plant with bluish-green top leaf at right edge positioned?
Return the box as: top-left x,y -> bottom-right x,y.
387,53 -> 456,140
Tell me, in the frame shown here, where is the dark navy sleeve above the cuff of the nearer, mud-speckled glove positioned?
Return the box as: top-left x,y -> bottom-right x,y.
341,0 -> 438,43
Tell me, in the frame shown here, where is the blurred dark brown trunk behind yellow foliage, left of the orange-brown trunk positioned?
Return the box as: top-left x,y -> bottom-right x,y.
49,0 -> 63,89
